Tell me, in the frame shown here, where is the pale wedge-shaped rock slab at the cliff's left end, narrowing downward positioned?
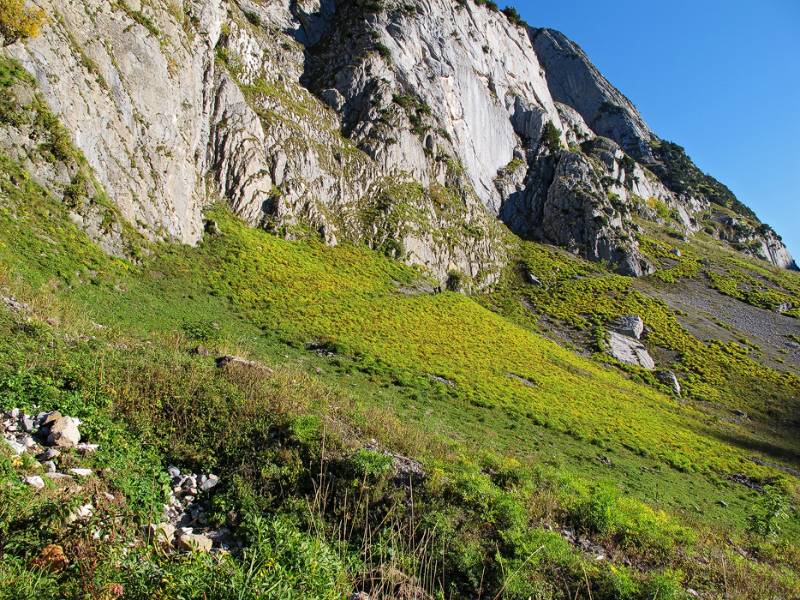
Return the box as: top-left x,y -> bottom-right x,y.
7,0 -> 225,242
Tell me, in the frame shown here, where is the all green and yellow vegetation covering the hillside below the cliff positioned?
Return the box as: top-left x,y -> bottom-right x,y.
0,143 -> 800,598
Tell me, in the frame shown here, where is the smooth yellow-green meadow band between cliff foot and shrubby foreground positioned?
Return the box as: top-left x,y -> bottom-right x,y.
0,146 -> 796,596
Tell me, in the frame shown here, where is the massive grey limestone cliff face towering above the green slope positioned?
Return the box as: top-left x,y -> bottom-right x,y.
0,0 -> 794,280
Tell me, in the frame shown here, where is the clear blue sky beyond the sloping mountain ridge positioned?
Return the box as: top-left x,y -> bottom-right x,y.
501,0 -> 800,259
